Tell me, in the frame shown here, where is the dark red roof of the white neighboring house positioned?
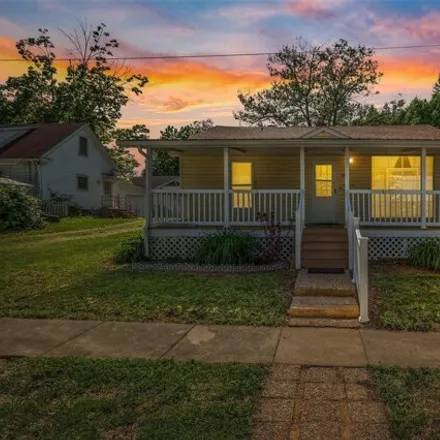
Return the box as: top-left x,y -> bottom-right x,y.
0,123 -> 85,159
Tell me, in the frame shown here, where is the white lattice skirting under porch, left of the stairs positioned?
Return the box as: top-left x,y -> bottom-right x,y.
149,236 -> 295,261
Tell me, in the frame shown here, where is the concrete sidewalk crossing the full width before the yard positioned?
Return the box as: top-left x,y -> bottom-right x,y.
0,318 -> 440,368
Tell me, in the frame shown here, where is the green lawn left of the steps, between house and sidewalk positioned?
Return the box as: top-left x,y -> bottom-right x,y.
0,219 -> 289,325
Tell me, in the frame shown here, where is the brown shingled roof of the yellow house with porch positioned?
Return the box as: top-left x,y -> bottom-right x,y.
191,125 -> 440,140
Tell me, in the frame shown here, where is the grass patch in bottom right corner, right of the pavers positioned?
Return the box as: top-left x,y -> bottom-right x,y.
373,367 -> 440,440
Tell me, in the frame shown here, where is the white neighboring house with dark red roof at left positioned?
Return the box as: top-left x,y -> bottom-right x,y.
0,123 -> 143,209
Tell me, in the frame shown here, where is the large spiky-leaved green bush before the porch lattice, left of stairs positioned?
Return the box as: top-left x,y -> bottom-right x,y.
195,229 -> 259,265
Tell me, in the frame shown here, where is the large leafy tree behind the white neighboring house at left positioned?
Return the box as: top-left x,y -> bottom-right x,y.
0,23 -> 148,177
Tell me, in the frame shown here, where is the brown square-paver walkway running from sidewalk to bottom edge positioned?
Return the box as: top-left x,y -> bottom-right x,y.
253,365 -> 391,440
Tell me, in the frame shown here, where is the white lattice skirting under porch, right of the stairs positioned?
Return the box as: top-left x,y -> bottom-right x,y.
368,237 -> 428,260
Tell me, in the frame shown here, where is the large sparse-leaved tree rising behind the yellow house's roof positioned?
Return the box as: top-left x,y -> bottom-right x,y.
234,39 -> 382,127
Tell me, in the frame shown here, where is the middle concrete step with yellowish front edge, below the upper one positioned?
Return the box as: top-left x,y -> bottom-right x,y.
287,296 -> 359,319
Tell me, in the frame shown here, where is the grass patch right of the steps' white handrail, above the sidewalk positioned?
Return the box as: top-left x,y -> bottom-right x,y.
371,265 -> 440,331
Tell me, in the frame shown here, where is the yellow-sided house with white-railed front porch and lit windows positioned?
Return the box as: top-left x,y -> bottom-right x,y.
121,125 -> 440,267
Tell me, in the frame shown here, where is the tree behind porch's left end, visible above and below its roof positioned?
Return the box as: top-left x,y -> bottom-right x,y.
153,119 -> 214,176
